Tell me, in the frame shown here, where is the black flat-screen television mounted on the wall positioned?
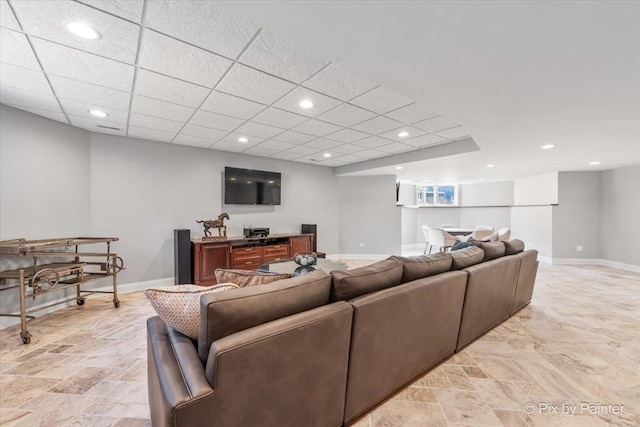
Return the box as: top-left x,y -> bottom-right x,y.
224,167 -> 281,205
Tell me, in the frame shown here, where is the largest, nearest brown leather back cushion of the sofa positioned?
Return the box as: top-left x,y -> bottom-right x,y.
198,270 -> 331,361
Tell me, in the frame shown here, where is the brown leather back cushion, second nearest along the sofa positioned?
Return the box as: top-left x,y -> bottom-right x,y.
331,259 -> 403,301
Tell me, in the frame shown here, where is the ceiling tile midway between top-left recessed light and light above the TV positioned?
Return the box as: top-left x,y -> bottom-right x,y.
134,70 -> 209,107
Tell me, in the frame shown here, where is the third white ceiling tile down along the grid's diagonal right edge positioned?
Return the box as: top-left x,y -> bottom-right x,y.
303,63 -> 378,101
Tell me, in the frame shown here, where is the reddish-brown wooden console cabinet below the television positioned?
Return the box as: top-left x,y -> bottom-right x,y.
191,234 -> 313,286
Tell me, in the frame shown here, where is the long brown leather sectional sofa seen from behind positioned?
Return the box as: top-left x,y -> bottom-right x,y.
147,241 -> 538,426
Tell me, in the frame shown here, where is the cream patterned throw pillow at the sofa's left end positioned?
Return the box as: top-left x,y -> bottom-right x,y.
144,283 -> 238,339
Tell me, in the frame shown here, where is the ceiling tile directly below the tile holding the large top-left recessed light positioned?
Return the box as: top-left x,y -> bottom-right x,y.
32,38 -> 134,92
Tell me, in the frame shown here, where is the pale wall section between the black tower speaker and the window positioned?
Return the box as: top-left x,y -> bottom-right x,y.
338,175 -> 402,255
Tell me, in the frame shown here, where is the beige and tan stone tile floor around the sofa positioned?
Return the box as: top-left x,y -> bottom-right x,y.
0,260 -> 640,427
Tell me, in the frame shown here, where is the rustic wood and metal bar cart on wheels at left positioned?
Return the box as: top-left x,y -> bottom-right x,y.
0,237 -> 124,344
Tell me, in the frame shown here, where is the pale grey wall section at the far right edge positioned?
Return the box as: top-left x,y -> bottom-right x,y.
600,165 -> 640,266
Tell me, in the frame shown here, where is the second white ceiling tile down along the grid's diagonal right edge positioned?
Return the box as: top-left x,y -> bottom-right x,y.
240,30 -> 328,84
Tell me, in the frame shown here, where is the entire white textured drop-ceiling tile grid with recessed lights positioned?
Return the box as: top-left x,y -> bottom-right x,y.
0,0 -> 468,171
